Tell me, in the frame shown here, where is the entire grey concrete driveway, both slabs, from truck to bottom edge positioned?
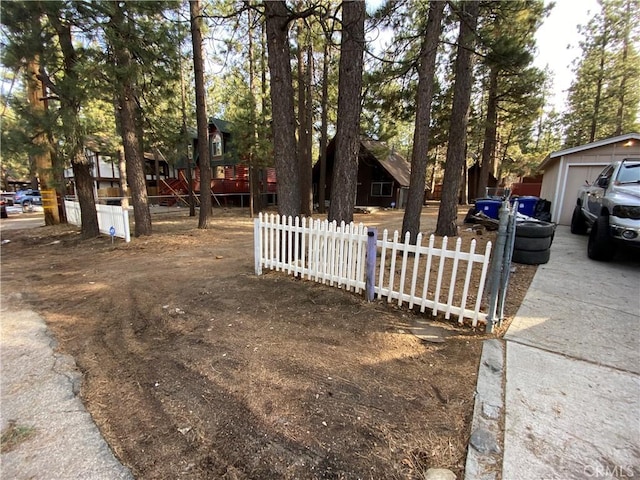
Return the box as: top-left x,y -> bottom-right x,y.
502,227 -> 640,480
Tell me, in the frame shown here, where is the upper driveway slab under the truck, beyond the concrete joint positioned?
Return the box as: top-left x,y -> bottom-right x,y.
505,227 -> 640,373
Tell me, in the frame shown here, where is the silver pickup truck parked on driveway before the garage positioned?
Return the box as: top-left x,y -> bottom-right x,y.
571,158 -> 640,261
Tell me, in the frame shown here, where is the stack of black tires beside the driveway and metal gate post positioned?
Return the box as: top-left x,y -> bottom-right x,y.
512,220 -> 556,265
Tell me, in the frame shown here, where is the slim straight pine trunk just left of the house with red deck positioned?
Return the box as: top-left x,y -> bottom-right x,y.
189,0 -> 211,229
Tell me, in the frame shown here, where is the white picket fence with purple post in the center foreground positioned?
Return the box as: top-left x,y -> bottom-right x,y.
254,214 -> 491,326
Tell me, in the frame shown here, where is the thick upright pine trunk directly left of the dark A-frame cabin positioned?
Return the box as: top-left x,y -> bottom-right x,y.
329,1 -> 365,223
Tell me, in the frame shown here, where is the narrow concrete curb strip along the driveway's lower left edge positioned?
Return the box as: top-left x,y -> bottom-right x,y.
465,339 -> 505,480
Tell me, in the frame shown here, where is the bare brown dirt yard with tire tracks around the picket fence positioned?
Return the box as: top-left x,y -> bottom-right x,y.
1,206 -> 535,479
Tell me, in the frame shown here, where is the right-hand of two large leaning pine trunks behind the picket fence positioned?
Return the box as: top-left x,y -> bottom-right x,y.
436,1 -> 479,237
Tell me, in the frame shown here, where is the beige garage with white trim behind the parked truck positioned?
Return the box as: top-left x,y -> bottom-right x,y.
538,133 -> 640,225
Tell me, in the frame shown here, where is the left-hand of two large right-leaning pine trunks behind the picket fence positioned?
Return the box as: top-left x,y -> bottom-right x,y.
402,1 -> 445,244
